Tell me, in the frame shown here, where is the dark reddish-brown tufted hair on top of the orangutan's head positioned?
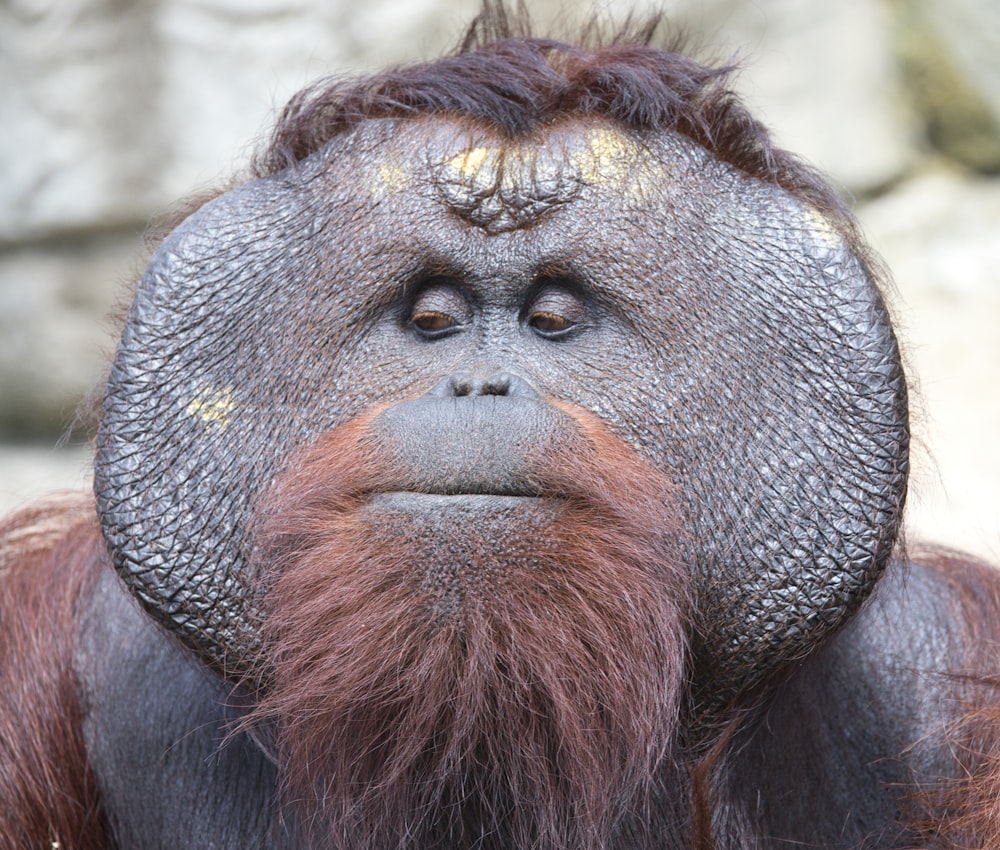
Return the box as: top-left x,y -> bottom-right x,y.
254,2 -> 858,237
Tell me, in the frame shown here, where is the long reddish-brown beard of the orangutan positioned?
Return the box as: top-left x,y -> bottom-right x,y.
246,404 -> 689,850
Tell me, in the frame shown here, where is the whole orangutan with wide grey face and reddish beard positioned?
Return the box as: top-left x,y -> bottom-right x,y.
0,2 -> 1000,850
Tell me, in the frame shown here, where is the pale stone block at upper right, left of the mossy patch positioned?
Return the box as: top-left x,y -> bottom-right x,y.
684,0 -> 917,194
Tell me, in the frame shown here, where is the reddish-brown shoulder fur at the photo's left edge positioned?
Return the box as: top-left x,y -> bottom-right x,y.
0,496 -> 107,850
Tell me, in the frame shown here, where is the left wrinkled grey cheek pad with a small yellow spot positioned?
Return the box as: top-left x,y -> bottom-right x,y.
95,178 -> 356,672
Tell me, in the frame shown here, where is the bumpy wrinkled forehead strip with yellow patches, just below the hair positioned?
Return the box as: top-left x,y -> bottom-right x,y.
364,119 -> 664,232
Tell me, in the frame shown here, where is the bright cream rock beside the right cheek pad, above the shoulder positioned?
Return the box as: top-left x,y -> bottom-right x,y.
861,171 -> 1000,564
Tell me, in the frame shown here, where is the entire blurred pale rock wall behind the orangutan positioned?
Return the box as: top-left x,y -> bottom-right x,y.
0,0 -> 1000,562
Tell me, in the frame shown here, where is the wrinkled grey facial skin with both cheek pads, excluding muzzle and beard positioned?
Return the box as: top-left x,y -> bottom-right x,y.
96,120 -> 907,694
